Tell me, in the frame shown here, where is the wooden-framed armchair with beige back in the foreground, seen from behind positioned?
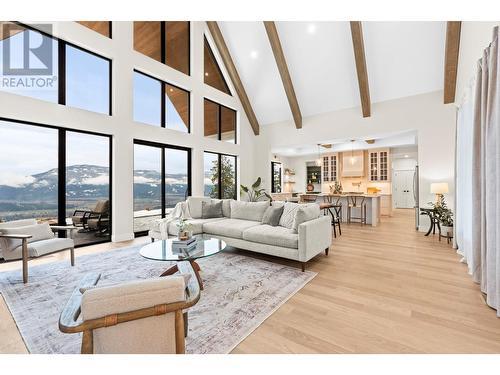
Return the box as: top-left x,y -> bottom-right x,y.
59,262 -> 200,354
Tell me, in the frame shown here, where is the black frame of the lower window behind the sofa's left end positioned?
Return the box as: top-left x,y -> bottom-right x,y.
132,138 -> 193,237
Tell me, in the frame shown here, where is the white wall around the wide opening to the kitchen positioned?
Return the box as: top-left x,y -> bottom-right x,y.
255,91 -> 456,229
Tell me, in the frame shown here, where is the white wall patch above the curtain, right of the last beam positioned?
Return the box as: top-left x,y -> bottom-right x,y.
455,21 -> 500,104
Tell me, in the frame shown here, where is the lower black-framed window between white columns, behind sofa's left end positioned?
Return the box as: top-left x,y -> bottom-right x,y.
134,141 -> 191,234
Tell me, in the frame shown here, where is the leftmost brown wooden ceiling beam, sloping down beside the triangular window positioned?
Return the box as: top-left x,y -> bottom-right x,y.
207,21 -> 260,135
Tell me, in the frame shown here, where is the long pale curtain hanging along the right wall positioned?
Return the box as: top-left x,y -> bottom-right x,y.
456,27 -> 500,317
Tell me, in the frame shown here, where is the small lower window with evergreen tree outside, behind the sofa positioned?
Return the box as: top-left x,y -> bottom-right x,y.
203,152 -> 237,199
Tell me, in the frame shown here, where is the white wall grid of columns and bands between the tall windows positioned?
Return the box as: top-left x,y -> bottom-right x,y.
0,22 -> 255,241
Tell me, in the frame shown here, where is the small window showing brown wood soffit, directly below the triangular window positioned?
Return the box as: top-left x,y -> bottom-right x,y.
204,99 -> 236,143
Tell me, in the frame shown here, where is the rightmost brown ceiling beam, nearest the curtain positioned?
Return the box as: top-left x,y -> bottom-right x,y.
444,21 -> 462,104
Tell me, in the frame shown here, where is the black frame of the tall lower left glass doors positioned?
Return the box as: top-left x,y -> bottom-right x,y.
0,116 -> 113,248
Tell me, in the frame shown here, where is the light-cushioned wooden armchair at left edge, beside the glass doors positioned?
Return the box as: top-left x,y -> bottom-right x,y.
0,219 -> 76,284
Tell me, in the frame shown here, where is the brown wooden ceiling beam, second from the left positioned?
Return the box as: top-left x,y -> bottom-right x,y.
264,21 -> 302,129
